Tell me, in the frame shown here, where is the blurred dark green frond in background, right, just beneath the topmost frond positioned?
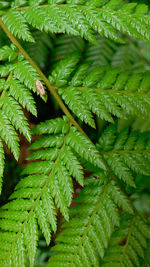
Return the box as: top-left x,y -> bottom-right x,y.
85,36 -> 149,73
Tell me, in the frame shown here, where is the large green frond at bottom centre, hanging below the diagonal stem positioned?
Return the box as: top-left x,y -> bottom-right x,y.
48,174 -> 133,267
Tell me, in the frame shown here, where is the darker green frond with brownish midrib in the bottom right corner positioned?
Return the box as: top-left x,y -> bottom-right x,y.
100,214 -> 150,267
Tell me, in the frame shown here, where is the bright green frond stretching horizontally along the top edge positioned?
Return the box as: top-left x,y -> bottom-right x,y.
2,0 -> 150,43
